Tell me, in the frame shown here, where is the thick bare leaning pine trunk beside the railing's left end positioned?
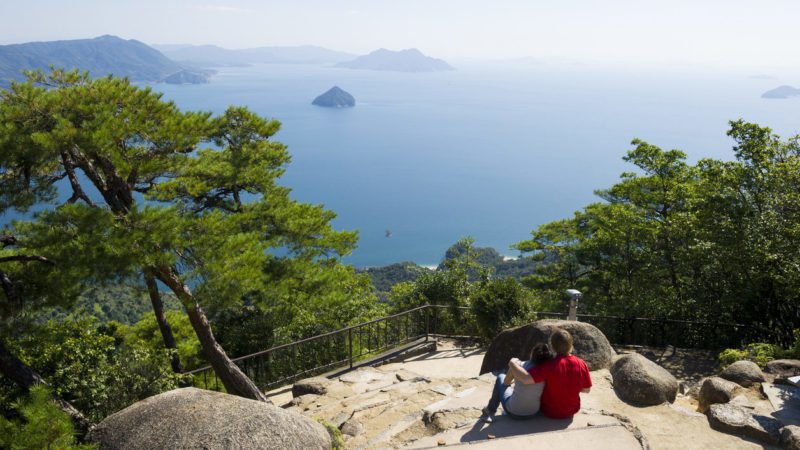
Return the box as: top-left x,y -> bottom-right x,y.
151,267 -> 268,402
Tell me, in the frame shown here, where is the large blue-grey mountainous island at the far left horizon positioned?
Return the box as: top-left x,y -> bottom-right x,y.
0,35 -> 210,87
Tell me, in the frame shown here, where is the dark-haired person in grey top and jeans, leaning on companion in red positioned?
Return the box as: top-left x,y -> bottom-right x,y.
481,344 -> 554,423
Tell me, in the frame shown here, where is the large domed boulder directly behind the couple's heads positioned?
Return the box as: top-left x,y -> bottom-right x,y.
480,320 -> 616,374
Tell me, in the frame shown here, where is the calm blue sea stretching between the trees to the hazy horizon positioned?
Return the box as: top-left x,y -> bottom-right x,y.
7,62 -> 800,267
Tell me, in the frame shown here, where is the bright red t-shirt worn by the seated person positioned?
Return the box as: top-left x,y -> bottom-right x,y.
528,355 -> 592,419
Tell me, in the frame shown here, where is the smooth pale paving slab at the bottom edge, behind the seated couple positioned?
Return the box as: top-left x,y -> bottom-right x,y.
412,424 -> 642,450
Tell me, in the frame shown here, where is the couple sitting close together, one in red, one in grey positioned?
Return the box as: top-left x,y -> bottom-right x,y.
481,328 -> 592,422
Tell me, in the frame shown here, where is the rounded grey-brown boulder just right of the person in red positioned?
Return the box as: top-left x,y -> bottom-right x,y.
611,353 -> 678,406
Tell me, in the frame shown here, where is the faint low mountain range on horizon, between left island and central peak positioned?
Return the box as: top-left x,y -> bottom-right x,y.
153,45 -> 356,67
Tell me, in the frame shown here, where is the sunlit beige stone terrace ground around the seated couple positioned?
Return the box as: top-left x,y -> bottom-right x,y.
270,345 -> 771,450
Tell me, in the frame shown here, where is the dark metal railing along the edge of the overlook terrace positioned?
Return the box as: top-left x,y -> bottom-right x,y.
184,305 -> 763,390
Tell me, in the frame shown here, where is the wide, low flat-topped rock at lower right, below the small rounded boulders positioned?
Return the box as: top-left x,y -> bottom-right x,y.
707,403 -> 781,445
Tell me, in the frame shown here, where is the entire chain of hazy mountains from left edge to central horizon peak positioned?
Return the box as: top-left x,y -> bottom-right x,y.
0,35 -> 453,88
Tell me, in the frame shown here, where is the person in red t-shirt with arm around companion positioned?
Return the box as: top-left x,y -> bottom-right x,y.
508,328 -> 592,419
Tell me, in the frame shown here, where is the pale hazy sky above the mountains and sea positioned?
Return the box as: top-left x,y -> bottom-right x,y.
0,0 -> 800,67
